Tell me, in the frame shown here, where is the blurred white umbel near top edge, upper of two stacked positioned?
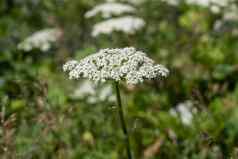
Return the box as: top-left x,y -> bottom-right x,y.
85,2 -> 136,18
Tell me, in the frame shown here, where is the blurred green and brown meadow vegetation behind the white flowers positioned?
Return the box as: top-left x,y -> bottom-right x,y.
0,0 -> 238,159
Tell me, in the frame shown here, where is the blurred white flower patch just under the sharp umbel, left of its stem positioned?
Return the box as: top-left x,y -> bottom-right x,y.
71,80 -> 116,104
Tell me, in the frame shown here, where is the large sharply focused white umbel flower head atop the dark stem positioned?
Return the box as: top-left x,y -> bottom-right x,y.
63,47 -> 169,84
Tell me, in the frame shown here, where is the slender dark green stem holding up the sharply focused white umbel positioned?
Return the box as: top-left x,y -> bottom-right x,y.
115,82 -> 132,159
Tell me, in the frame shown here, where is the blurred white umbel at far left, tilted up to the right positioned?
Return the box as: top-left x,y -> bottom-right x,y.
17,28 -> 61,52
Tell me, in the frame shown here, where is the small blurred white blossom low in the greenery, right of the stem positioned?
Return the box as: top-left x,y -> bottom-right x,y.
170,100 -> 197,125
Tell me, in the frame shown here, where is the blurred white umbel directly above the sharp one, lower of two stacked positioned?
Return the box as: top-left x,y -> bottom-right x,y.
92,16 -> 145,37
